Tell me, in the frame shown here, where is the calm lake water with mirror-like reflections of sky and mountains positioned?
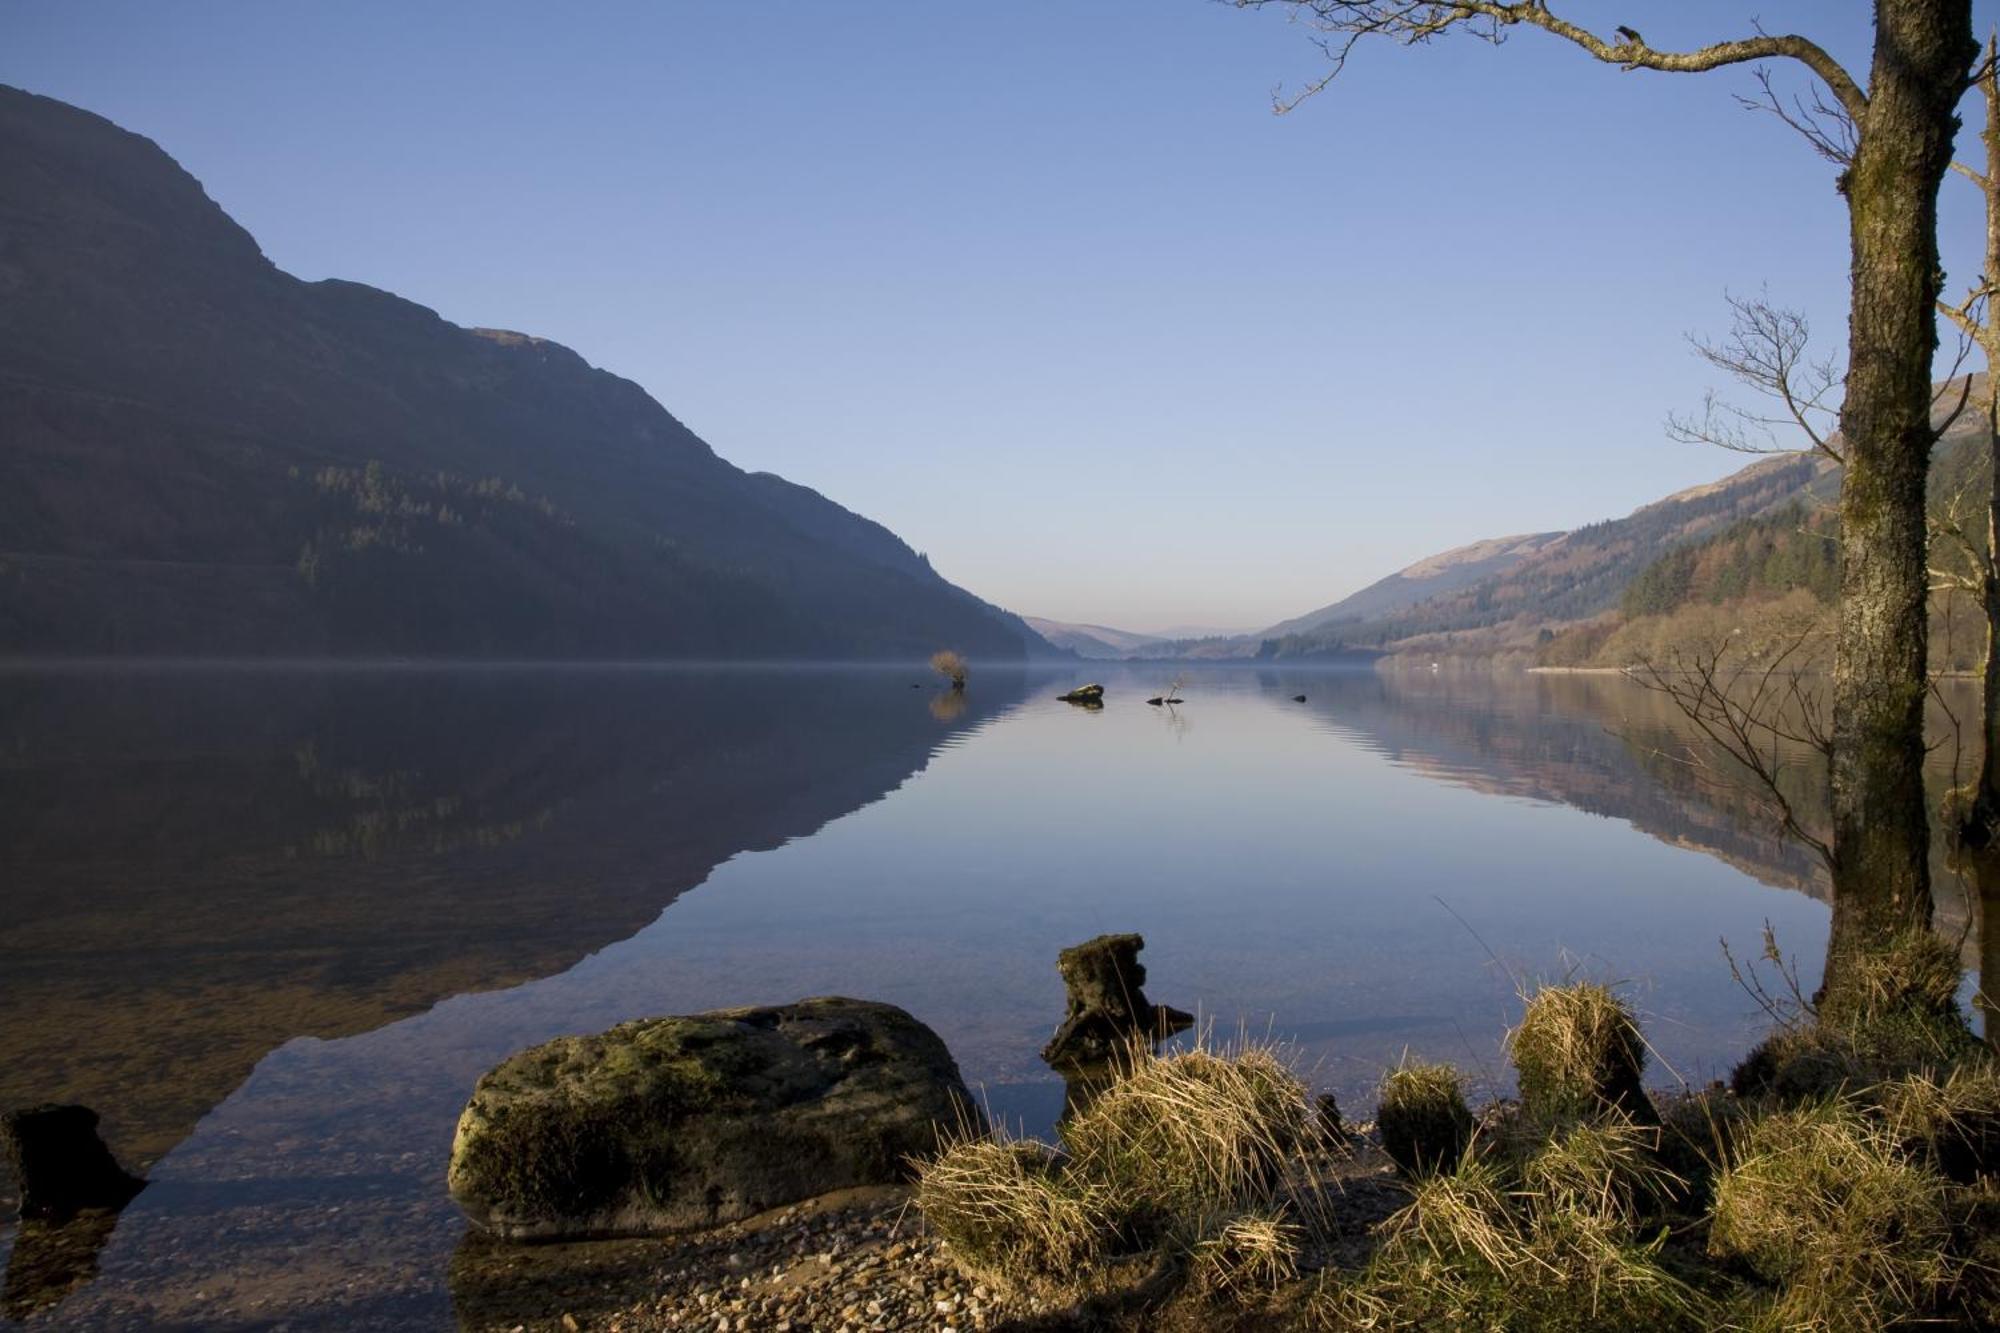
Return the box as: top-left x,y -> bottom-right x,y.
0,669 -> 1976,1327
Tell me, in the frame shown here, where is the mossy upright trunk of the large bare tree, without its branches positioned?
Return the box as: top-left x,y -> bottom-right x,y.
1822,0 -> 1978,995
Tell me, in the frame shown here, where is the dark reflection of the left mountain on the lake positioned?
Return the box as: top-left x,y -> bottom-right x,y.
0,669 -> 1024,1317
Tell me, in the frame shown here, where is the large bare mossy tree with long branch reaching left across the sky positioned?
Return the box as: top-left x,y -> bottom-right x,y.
1236,0 -> 1980,987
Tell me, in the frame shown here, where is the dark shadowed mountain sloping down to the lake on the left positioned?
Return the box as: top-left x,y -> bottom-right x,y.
0,88 -> 1048,660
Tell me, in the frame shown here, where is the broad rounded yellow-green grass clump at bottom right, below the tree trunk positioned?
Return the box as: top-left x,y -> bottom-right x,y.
1708,1103 -> 1956,1333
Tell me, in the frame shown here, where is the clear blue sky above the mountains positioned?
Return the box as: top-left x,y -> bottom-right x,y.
0,0 -> 2000,630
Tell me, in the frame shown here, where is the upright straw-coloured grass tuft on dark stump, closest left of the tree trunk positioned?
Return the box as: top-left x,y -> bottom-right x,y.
1508,981 -> 1656,1125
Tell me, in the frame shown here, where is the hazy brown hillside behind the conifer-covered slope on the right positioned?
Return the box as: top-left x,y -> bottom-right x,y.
1238,454 -> 1838,658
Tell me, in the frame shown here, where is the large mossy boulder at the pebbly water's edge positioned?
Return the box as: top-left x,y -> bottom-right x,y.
446,999 -> 980,1241
